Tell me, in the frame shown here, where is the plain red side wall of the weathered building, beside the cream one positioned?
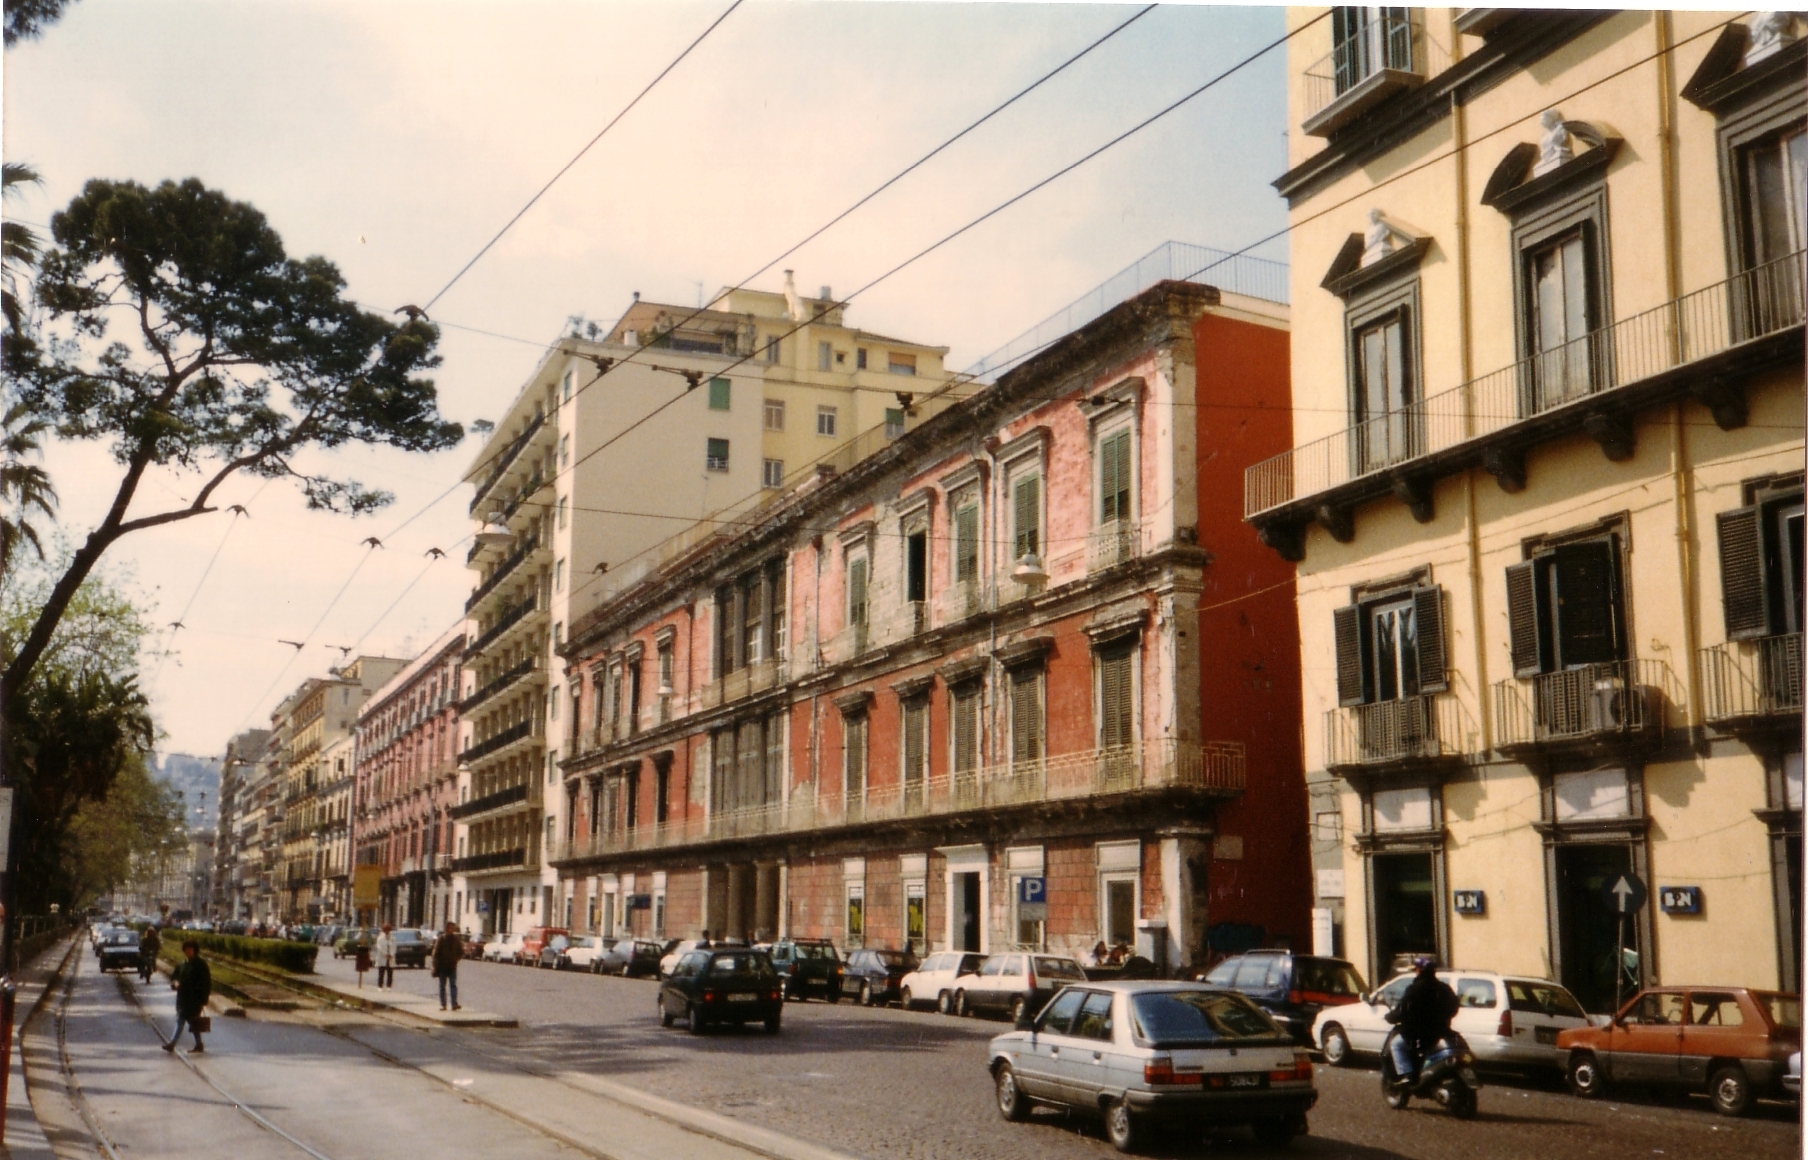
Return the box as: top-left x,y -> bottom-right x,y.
1193,314 -> 1313,950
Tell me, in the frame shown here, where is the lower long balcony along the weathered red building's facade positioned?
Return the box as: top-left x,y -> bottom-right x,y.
550,741 -> 1246,864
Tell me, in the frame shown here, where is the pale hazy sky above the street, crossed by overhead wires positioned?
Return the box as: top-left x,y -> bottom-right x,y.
4,0 -> 1285,753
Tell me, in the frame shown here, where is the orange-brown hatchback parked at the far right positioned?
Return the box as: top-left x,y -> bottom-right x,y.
1557,987 -> 1803,1115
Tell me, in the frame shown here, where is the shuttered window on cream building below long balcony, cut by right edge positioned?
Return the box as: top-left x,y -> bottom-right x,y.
1716,482 -> 1803,640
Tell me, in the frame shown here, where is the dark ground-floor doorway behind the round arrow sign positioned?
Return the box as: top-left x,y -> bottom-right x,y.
1557,846 -> 1642,1014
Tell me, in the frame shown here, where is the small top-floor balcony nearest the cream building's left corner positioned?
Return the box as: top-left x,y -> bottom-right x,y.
1300,7 -> 1450,137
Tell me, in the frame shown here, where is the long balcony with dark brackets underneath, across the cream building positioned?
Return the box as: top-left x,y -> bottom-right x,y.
1244,253 -> 1803,545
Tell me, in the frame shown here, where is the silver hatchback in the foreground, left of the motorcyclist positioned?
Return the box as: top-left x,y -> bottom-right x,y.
987,981 -> 1318,1151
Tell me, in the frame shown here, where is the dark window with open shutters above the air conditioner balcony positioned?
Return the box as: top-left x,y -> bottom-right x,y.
1506,535 -> 1625,676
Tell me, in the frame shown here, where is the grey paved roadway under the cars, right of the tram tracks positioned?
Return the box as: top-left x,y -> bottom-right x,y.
320,956 -> 1803,1160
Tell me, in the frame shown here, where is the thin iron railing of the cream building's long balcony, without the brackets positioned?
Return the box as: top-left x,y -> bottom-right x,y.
1244,251 -> 1803,519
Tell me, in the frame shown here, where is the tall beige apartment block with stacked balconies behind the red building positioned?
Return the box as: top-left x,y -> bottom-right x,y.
452,273 -> 971,931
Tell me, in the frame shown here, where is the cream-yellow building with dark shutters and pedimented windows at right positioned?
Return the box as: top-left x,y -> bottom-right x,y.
1246,7 -> 1808,1012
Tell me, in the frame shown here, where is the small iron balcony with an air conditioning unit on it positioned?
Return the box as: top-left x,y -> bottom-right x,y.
1493,661 -> 1669,757
